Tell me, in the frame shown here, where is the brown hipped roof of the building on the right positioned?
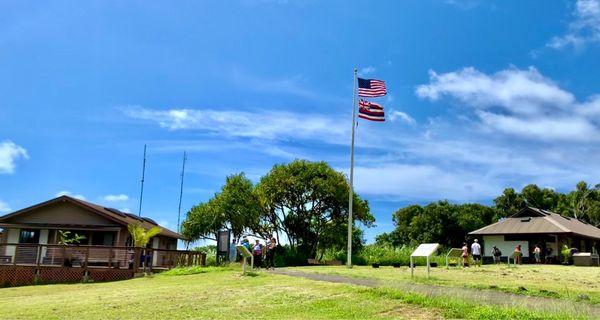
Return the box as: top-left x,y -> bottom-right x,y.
469,207 -> 600,240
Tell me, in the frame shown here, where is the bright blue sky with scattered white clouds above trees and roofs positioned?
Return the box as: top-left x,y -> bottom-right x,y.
0,0 -> 600,240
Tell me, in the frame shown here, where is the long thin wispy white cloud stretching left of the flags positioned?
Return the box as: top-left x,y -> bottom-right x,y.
123,107 -> 348,140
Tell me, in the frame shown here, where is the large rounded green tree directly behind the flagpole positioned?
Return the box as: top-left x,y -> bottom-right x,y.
257,160 -> 375,257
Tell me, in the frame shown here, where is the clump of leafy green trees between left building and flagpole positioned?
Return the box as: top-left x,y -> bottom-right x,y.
182,160 -> 375,257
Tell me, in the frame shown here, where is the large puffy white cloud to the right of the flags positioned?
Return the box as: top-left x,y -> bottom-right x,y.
416,67 -> 600,141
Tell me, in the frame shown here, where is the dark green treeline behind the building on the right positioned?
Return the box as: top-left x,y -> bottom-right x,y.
376,181 -> 600,247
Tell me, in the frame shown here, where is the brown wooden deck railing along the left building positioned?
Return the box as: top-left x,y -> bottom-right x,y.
0,243 -> 206,272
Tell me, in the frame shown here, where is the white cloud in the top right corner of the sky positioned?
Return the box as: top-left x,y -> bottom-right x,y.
547,0 -> 600,49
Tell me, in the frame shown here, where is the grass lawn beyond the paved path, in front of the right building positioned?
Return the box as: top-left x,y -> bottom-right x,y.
293,265 -> 600,304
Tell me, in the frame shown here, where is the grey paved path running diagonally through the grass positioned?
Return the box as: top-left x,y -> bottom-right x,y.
271,268 -> 600,319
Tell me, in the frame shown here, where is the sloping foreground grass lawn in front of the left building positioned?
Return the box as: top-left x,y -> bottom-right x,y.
0,267 -> 592,319
